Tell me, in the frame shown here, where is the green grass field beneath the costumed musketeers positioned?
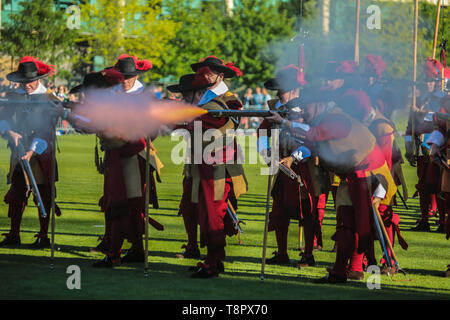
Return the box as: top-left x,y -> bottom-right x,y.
0,115 -> 450,300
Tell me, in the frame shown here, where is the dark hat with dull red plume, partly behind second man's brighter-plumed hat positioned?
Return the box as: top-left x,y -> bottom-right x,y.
69,67 -> 124,93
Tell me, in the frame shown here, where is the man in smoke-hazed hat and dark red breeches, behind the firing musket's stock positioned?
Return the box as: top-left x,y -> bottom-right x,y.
258,65 -> 321,267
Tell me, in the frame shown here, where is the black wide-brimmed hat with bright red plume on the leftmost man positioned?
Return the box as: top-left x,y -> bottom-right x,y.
6,56 -> 55,83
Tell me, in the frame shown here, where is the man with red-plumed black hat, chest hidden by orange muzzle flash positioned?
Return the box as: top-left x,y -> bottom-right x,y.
93,55 -> 162,267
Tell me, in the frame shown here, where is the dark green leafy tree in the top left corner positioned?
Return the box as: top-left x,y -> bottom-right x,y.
0,0 -> 77,78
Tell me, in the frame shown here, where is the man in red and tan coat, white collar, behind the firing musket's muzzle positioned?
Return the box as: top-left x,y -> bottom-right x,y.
184,58 -> 247,278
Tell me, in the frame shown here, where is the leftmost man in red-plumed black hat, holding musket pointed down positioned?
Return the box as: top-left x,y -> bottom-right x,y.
0,56 -> 61,248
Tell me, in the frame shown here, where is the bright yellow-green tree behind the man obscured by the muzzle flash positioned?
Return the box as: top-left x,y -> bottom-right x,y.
80,0 -> 179,80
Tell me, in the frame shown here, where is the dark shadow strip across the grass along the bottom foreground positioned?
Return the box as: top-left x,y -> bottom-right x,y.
0,254 -> 449,300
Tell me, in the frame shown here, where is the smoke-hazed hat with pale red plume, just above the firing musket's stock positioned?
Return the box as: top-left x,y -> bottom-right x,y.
264,65 -> 306,91
